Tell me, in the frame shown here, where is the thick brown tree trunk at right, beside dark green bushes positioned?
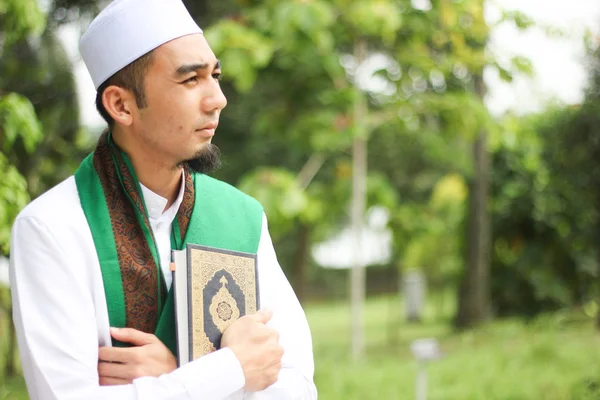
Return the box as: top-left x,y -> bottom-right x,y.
455,76 -> 491,328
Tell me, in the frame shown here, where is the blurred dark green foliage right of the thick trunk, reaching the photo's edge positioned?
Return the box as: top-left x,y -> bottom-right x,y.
492,30 -> 600,325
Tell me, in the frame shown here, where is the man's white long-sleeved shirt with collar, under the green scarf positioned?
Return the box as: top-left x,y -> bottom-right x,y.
10,177 -> 317,400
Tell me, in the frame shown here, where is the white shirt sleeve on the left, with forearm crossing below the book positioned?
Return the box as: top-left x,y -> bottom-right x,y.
10,216 -> 245,400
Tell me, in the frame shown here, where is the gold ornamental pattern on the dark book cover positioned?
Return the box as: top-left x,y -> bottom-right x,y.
189,249 -> 257,360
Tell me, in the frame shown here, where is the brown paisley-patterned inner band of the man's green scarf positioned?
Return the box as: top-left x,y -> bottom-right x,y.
93,132 -> 194,333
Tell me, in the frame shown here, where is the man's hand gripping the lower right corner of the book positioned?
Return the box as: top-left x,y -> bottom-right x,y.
221,310 -> 283,392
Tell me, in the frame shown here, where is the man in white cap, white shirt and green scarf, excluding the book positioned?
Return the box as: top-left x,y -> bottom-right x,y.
10,0 -> 317,400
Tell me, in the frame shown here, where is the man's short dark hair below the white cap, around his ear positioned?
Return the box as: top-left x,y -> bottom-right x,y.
96,51 -> 153,128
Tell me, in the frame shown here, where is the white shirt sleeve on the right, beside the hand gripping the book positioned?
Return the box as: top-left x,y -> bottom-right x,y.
244,214 -> 317,400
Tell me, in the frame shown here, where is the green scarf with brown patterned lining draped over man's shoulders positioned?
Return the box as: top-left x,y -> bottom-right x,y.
75,132 -> 263,354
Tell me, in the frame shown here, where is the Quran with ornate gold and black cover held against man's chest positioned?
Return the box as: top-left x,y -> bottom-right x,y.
171,243 -> 260,366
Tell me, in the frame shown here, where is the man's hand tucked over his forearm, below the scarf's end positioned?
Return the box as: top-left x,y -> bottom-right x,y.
98,328 -> 177,386
